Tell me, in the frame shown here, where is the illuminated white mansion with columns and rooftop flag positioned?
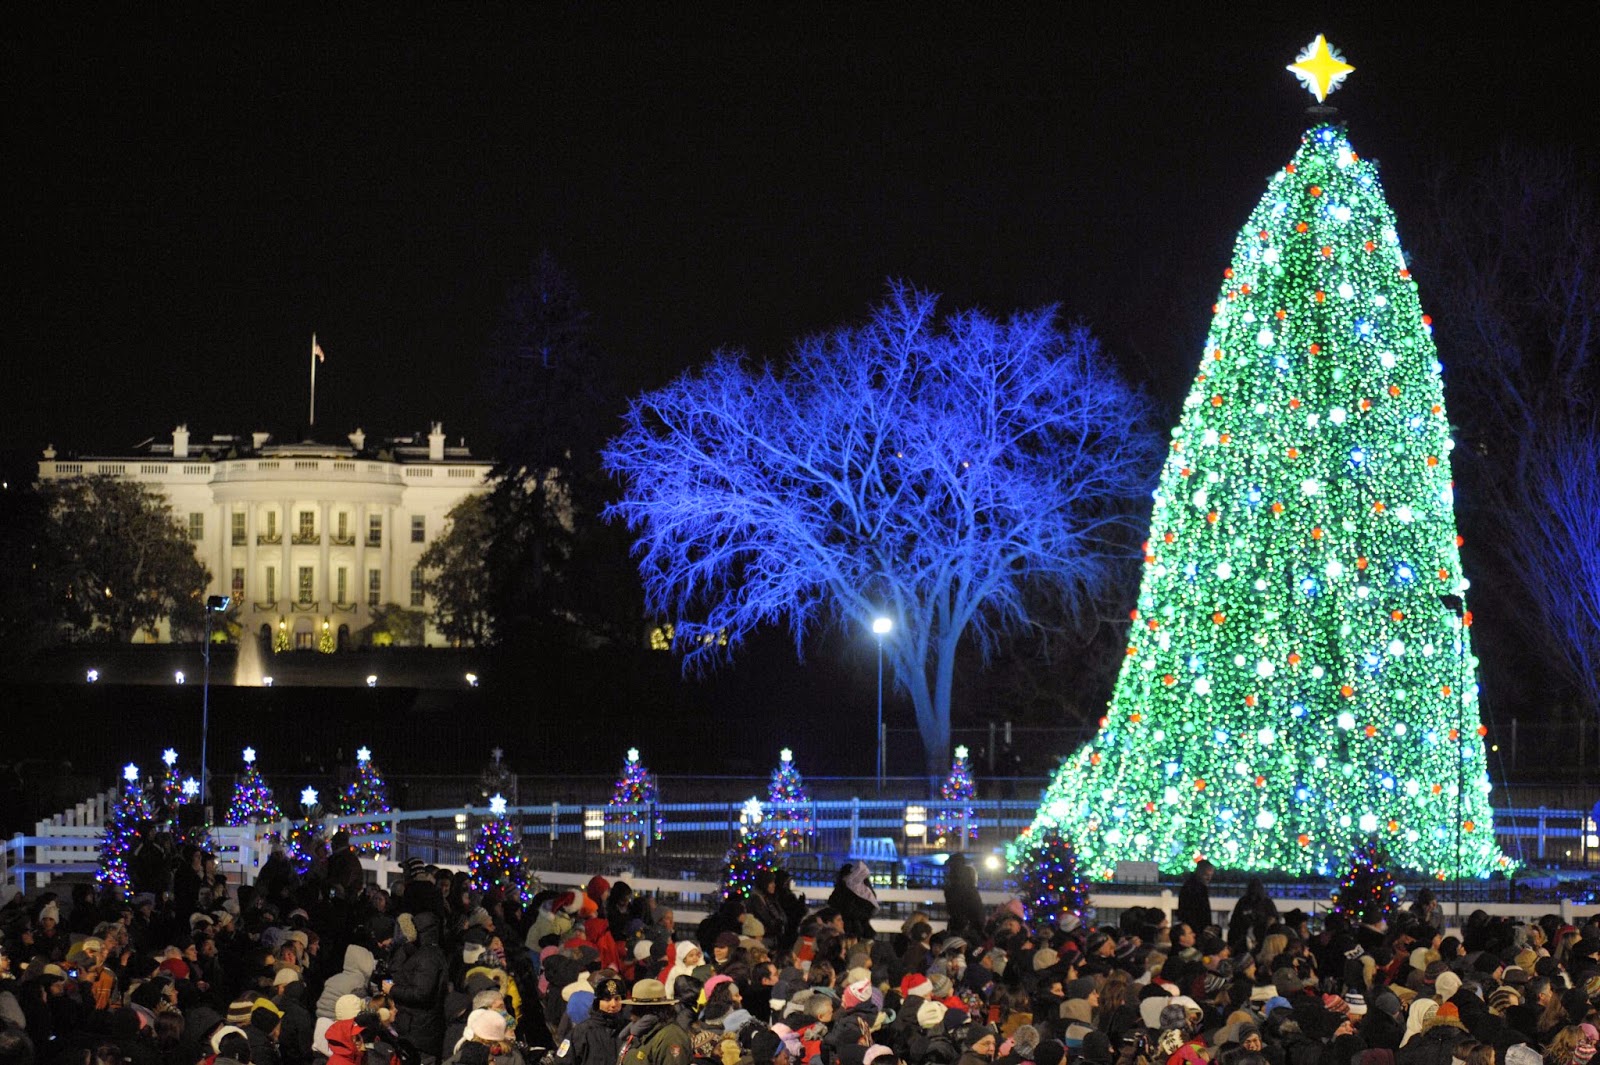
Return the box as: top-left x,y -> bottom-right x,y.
38,422 -> 493,648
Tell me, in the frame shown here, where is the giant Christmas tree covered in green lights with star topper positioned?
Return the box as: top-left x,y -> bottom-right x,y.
1034,37 -> 1507,878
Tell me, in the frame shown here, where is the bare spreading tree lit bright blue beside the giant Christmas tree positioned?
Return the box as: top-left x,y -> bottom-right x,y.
603,285 -> 1154,776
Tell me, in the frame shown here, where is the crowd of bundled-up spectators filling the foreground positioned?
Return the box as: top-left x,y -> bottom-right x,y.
0,833 -> 1600,1065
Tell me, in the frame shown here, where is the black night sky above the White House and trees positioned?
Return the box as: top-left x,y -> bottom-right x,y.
0,3 -> 1600,475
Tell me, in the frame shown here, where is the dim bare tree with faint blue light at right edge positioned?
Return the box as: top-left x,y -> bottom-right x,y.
1419,146 -> 1600,716
